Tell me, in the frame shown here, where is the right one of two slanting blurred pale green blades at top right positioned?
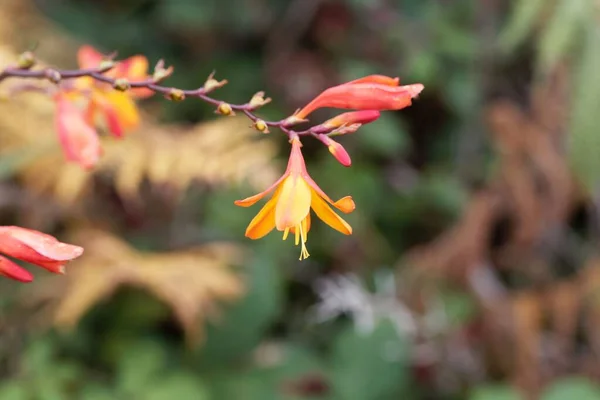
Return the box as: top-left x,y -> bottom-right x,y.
530,0 -> 594,71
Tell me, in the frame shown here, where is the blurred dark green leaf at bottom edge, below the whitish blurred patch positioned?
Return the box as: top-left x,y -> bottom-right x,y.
332,320 -> 409,400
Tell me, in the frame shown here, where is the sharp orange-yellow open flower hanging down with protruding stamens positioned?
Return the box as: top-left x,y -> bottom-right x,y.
235,137 -> 355,260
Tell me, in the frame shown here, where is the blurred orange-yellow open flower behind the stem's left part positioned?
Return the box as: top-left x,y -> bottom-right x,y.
75,46 -> 153,137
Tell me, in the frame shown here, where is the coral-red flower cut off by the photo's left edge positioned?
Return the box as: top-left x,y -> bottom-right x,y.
0,226 -> 83,282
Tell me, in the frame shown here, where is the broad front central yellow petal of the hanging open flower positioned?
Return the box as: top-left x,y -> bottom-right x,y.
275,174 -> 311,231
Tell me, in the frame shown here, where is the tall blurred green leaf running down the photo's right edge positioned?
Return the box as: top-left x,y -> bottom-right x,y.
569,26 -> 600,192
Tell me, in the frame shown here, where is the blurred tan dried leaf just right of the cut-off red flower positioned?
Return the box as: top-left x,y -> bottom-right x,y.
49,230 -> 244,344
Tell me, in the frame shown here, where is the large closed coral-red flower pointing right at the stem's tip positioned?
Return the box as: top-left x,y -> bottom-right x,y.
294,75 -> 424,120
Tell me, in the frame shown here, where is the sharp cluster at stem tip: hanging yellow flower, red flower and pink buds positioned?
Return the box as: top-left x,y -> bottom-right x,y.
235,75 -> 423,260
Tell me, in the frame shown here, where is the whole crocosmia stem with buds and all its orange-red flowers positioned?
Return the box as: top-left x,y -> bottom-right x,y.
0,46 -> 423,259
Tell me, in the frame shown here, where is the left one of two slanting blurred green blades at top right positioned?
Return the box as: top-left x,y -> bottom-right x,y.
500,0 -> 554,51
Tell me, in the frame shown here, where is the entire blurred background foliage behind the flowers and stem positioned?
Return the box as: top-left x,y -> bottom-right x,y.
0,0 -> 600,400
